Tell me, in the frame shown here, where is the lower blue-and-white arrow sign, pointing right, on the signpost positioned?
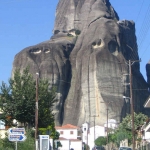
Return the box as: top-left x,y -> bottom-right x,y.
8,134 -> 27,142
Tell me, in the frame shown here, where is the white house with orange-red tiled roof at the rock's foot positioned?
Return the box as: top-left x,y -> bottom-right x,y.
55,124 -> 82,150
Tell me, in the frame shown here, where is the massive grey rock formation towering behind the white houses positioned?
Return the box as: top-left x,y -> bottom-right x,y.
13,0 -> 148,125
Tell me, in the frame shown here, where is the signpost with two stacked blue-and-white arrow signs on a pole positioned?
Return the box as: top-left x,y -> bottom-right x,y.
7,128 -> 27,150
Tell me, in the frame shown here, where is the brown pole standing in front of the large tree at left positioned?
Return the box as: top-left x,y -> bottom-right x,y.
35,73 -> 39,150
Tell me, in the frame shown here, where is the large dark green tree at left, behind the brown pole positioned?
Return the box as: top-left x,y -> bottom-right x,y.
0,68 -> 56,128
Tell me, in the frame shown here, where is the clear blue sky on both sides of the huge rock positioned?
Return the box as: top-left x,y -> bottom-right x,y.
0,0 -> 150,84
